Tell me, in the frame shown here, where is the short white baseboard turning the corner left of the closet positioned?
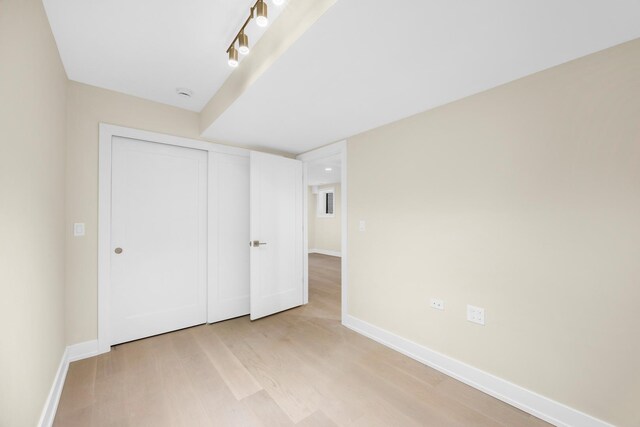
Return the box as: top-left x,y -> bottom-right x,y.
38,340 -> 98,427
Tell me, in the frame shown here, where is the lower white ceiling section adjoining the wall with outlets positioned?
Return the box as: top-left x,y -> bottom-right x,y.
204,0 -> 640,153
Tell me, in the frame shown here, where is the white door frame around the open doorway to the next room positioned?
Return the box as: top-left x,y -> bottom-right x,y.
296,140 -> 349,324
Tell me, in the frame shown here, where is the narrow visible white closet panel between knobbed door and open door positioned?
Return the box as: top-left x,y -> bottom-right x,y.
208,153 -> 249,323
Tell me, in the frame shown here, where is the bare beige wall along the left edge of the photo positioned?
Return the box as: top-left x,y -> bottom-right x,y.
0,0 -> 67,427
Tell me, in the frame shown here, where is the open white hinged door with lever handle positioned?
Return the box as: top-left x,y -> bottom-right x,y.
250,151 -> 304,320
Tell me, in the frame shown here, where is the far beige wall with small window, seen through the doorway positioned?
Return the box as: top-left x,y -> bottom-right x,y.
308,184 -> 342,252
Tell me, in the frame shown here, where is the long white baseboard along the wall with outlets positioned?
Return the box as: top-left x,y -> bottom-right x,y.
342,316 -> 612,427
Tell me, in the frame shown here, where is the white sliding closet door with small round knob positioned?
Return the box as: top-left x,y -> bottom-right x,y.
109,137 -> 207,345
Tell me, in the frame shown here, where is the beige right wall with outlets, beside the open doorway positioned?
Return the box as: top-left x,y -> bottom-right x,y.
348,40 -> 640,426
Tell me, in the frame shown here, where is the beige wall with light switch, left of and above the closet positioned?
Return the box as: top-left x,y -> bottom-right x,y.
66,82 -> 204,344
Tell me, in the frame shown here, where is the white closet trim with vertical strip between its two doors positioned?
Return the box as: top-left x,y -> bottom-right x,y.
98,123 -> 249,354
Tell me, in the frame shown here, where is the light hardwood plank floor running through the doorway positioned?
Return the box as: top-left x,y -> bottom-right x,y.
54,254 -> 547,427
